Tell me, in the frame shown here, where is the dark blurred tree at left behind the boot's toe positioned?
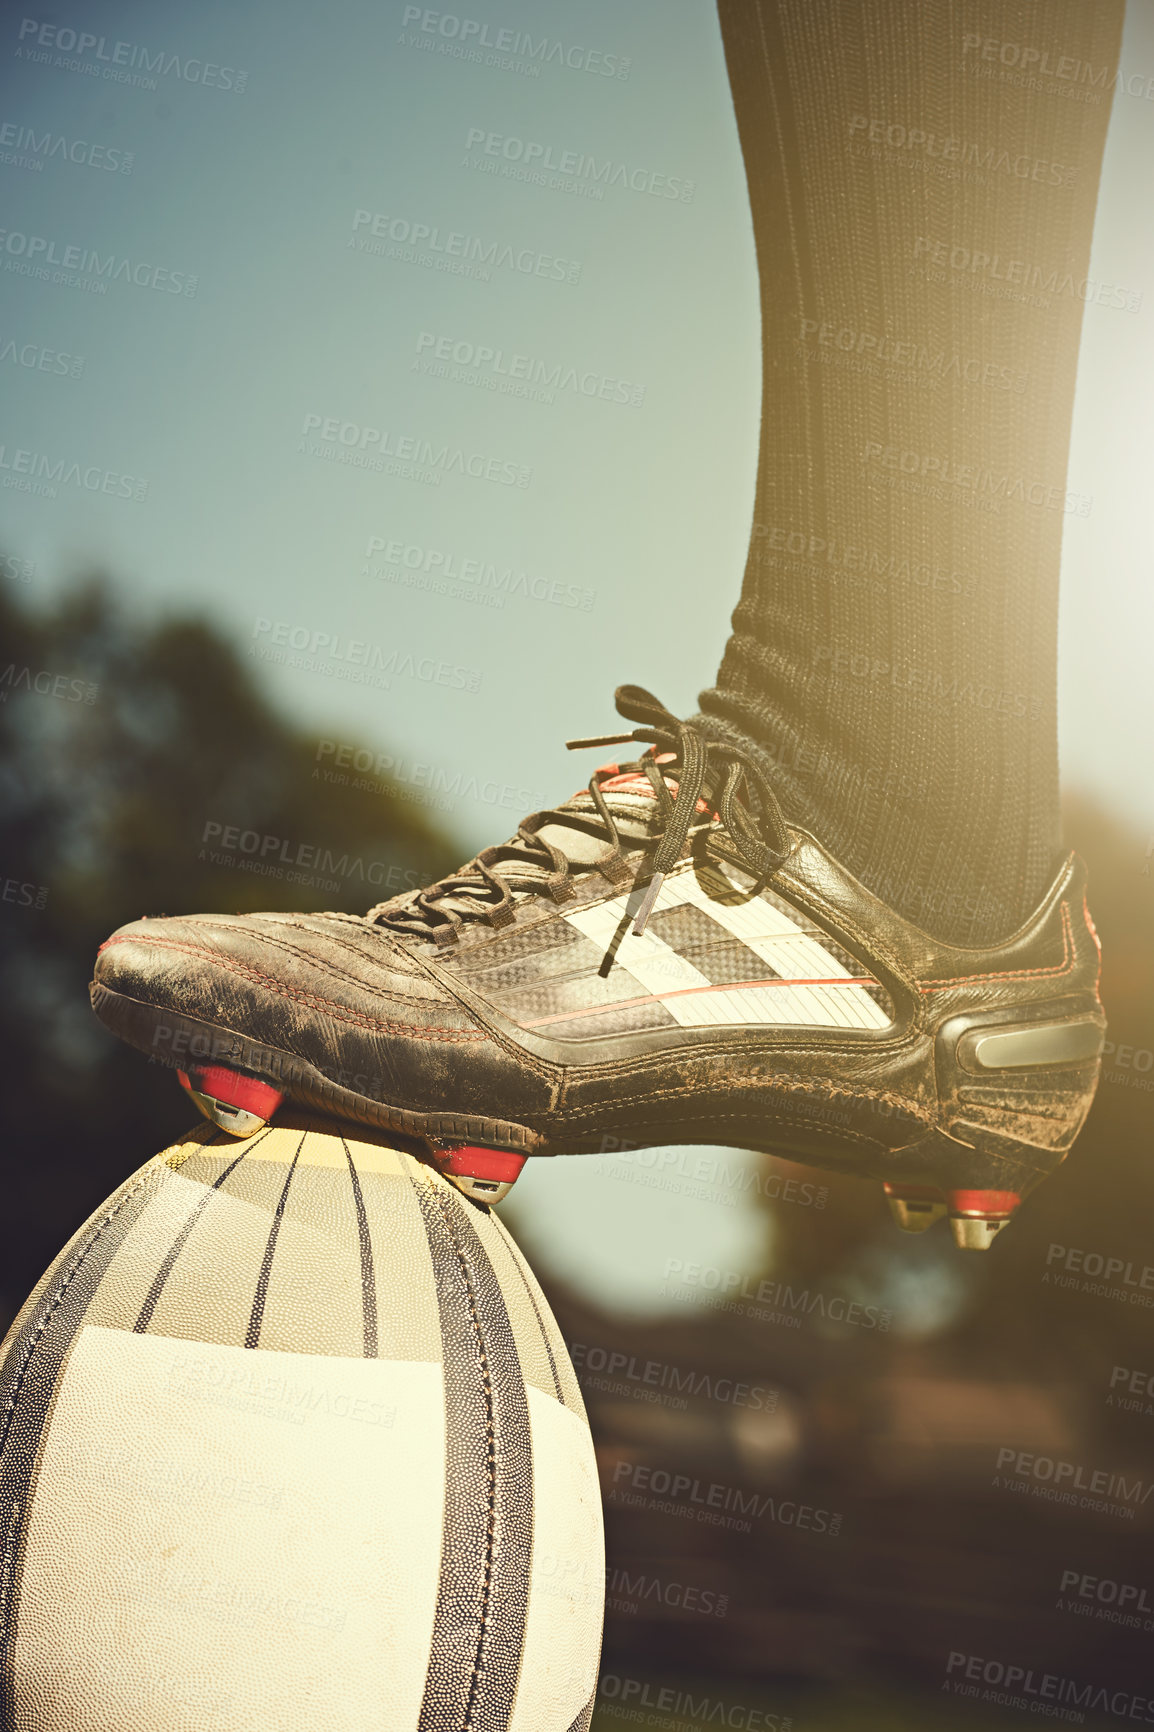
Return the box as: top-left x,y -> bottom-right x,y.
0,580 -> 459,1322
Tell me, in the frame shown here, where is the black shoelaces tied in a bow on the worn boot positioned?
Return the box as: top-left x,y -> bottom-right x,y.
367,686 -> 790,944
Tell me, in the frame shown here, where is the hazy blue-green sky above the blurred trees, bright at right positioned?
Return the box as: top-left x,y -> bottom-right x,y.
0,0 -> 1154,1308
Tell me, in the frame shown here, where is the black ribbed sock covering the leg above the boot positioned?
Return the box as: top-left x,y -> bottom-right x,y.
702,0 -> 1123,944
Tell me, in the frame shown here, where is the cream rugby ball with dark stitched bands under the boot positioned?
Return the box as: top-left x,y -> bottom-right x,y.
0,1117 -> 605,1732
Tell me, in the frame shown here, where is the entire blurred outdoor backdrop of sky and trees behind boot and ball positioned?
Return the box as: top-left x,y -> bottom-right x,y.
0,0 -> 1154,1732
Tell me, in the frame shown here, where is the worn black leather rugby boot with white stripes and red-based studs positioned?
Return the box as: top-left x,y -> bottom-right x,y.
92,686 -> 1104,1249
